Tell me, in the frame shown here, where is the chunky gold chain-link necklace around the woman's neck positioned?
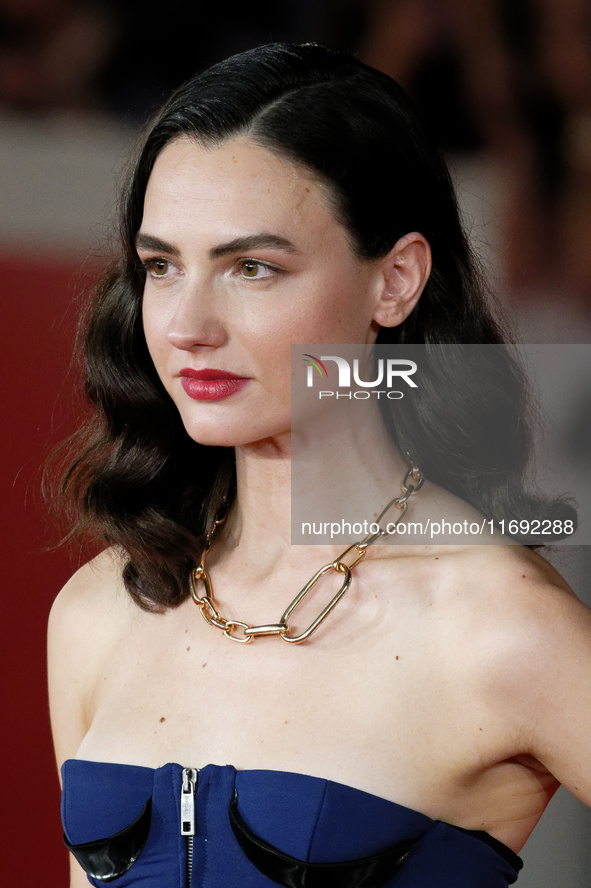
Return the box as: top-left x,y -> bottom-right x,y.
191,465 -> 425,644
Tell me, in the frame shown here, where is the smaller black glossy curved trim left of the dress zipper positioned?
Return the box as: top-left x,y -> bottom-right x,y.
64,796 -> 152,882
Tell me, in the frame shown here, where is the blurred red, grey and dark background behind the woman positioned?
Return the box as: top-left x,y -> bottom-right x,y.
0,0 -> 591,888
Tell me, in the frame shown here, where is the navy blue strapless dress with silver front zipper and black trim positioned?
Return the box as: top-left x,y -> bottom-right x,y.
62,759 -> 522,888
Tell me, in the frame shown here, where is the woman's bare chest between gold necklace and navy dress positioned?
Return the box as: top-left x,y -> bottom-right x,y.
78,596 -> 494,806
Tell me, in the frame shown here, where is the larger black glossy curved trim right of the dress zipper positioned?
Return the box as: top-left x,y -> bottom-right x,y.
229,792 -> 418,888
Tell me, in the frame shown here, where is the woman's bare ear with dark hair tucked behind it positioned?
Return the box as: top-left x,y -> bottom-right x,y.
373,231 -> 431,327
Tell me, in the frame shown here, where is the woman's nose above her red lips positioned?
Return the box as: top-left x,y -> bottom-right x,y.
166,287 -> 228,350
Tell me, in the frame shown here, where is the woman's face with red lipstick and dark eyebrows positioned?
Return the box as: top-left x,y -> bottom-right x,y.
137,137 -> 380,446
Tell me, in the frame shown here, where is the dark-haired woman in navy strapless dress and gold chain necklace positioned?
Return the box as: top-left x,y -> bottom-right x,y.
49,45 -> 591,888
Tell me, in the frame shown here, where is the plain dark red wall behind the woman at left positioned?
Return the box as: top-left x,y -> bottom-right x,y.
0,254 -> 98,888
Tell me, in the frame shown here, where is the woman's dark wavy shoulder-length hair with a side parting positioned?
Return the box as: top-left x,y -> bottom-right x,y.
51,44 -> 571,610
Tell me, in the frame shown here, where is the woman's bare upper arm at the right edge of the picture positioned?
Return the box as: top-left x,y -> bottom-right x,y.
485,552 -> 591,807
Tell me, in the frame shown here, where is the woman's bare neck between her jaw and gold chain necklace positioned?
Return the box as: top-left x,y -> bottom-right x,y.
224,400 -> 408,562
